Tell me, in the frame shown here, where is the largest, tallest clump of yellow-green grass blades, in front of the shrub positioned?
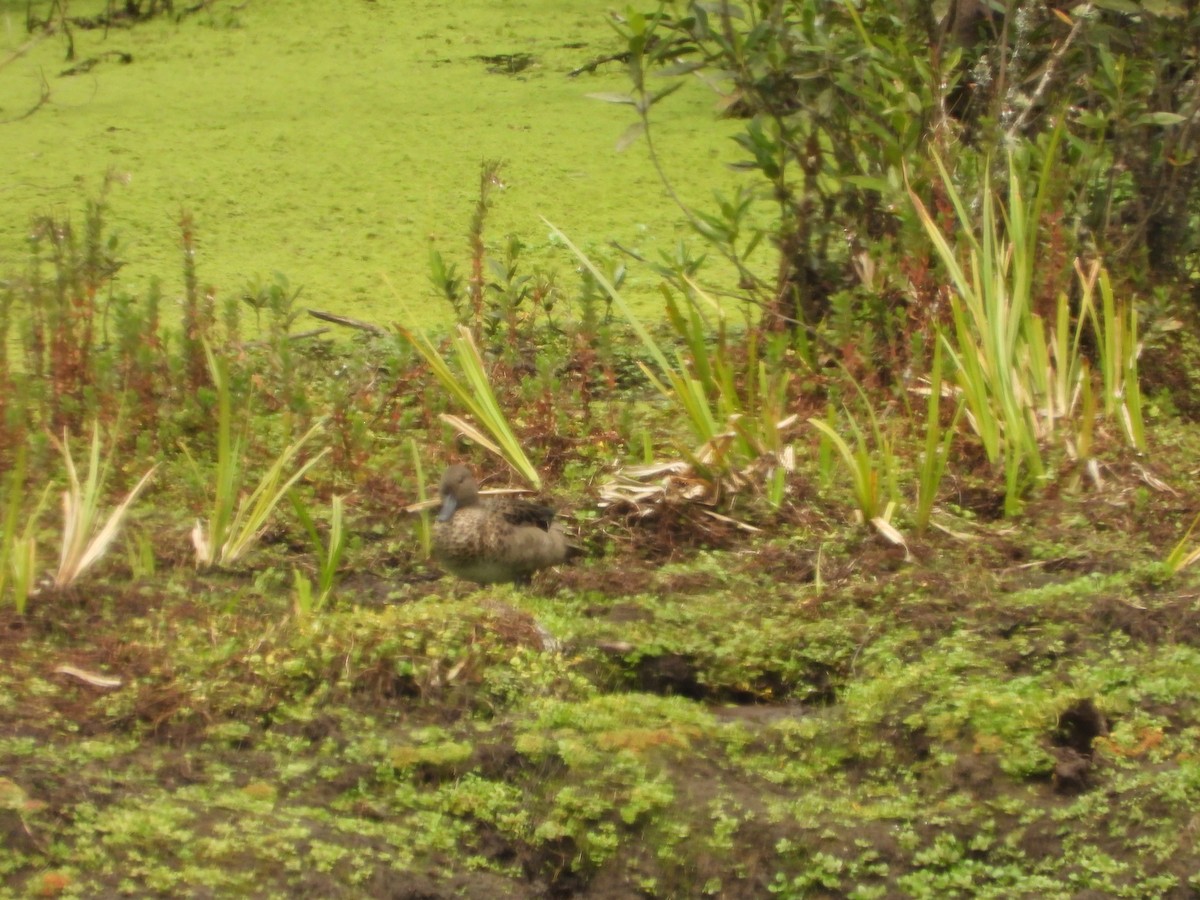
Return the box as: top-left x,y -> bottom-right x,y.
911,150 -> 1145,520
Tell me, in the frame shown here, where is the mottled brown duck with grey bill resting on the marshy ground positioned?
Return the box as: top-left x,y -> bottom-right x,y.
433,466 -> 575,584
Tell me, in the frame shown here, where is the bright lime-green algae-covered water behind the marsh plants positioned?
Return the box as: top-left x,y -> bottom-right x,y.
0,0 -> 737,323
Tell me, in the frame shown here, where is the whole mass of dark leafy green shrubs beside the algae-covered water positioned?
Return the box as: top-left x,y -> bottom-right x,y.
609,0 -> 1200,377
